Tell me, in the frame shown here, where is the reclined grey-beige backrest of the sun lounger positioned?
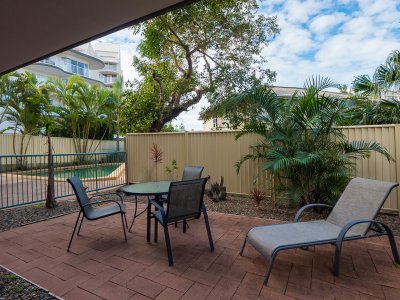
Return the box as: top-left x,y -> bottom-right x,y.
326,178 -> 399,235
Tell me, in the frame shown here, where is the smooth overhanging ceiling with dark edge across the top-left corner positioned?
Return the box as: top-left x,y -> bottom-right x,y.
0,0 -> 195,75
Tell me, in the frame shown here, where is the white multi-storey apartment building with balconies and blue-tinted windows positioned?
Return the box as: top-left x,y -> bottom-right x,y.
21,43 -> 122,87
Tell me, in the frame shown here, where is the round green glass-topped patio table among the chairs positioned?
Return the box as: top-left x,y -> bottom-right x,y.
119,180 -> 172,243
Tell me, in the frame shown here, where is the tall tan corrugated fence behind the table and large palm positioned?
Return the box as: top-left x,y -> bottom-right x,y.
126,125 -> 400,212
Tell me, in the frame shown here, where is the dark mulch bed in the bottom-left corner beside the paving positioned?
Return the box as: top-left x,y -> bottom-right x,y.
0,266 -> 59,300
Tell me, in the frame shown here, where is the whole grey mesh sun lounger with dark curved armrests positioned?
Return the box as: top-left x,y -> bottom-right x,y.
240,178 -> 400,284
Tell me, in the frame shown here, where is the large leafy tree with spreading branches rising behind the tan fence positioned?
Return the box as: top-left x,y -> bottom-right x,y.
121,0 -> 279,132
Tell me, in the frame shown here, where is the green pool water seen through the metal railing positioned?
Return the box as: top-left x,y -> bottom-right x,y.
35,164 -> 120,179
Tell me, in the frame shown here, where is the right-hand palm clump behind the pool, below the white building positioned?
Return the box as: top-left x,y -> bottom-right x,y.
47,75 -> 118,153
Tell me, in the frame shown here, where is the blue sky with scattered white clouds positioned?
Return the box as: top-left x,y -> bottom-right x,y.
94,0 -> 400,130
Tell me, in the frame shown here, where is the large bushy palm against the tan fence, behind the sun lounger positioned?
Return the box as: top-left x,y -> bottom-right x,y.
225,77 -> 392,205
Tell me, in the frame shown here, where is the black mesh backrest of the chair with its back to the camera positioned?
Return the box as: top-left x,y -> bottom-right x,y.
167,178 -> 207,222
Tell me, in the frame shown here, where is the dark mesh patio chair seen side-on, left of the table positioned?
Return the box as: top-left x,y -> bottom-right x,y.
67,176 -> 128,252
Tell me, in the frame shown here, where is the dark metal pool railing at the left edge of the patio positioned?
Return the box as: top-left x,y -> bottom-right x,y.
0,152 -> 126,209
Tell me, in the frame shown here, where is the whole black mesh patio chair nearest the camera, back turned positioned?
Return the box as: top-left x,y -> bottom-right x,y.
150,178 -> 214,266
